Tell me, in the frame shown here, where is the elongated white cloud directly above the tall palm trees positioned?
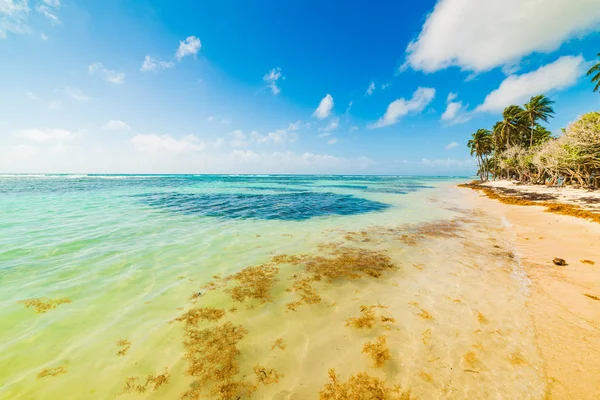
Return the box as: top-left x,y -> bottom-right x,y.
475,56 -> 584,112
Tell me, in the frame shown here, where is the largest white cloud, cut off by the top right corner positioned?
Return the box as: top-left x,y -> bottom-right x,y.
405,0 -> 600,72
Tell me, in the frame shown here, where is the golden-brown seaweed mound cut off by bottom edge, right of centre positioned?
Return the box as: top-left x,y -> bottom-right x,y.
319,368 -> 411,400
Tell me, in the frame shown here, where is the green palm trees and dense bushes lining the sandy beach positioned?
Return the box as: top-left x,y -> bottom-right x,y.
467,96 -> 600,187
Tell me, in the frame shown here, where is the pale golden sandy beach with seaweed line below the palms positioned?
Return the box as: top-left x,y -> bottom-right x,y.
461,181 -> 600,400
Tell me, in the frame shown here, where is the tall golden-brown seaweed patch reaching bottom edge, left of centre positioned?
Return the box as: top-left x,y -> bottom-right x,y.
181,322 -> 256,400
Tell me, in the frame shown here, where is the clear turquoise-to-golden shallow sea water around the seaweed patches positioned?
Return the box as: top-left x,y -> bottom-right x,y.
0,175 -> 546,399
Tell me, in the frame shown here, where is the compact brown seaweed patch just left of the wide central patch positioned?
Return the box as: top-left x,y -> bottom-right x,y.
225,264 -> 279,303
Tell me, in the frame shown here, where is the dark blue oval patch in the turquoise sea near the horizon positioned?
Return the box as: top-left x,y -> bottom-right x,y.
134,192 -> 390,221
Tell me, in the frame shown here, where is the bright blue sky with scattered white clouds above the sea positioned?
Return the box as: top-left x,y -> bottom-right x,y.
0,0 -> 600,175
